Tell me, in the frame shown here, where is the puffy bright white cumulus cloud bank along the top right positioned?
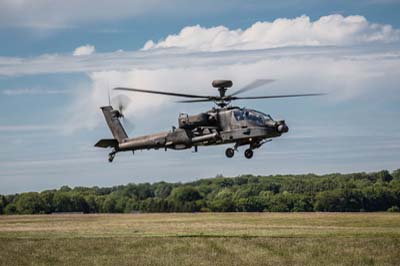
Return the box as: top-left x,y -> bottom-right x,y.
143,14 -> 400,51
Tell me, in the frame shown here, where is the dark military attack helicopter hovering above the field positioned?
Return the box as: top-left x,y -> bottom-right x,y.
95,79 -> 323,162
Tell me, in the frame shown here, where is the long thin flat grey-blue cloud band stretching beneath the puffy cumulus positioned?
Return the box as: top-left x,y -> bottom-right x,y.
0,44 -> 400,77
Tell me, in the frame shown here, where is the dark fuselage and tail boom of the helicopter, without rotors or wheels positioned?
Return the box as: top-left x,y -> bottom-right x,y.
110,107 -> 288,158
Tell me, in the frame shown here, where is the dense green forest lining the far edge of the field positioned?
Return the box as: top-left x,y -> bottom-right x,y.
0,169 -> 400,214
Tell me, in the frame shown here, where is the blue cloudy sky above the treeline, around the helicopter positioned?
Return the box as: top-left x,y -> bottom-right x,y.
0,0 -> 400,194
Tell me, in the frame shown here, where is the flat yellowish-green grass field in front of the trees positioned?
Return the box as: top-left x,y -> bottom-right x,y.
0,213 -> 400,265
